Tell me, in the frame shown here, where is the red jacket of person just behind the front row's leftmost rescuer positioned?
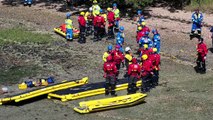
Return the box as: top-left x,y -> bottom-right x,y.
111,50 -> 124,64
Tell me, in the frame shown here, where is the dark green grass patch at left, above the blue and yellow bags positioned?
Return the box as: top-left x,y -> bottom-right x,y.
0,66 -> 41,85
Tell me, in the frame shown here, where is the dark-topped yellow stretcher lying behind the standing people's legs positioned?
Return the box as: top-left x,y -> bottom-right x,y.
48,80 -> 142,102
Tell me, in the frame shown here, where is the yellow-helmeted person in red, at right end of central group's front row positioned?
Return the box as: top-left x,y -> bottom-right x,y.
141,54 -> 154,93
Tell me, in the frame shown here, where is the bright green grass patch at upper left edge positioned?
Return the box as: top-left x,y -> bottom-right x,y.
0,27 -> 53,45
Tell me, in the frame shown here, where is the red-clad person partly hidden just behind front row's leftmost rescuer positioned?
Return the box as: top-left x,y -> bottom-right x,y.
111,45 -> 124,77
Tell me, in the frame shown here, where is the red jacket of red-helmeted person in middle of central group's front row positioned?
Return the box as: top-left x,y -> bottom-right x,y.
128,63 -> 141,77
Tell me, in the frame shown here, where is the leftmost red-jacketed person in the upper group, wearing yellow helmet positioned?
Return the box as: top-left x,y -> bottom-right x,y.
78,12 -> 86,43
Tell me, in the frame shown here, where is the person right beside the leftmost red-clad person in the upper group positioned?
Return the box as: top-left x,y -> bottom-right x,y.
85,7 -> 94,36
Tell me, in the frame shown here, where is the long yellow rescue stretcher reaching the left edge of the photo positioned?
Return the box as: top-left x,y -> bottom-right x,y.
0,77 -> 88,105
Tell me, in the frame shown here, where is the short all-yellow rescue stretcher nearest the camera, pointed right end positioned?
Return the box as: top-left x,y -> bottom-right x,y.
74,93 -> 147,114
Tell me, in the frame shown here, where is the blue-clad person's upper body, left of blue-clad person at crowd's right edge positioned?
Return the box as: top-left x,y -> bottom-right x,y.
139,32 -> 153,48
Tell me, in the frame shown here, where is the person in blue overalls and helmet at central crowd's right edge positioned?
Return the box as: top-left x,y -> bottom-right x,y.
152,29 -> 160,53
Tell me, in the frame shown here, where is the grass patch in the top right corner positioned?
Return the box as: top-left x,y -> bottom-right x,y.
185,0 -> 213,13
